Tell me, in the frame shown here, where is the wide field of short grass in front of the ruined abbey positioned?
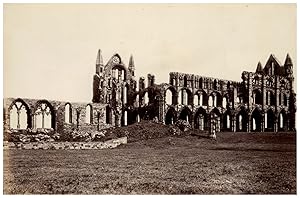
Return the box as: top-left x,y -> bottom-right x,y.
4,133 -> 296,194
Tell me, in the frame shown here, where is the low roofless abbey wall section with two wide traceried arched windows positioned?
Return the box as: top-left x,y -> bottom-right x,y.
4,98 -> 110,136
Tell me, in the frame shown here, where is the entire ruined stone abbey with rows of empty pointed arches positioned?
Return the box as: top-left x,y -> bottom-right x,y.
4,50 -> 296,137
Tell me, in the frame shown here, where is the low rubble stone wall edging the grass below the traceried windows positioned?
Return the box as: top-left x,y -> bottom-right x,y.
3,137 -> 127,150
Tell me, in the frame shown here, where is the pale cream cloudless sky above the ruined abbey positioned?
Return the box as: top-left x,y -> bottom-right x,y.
3,4 -> 297,102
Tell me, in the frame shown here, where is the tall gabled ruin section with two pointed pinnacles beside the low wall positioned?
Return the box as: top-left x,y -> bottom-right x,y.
92,49 -> 141,126
